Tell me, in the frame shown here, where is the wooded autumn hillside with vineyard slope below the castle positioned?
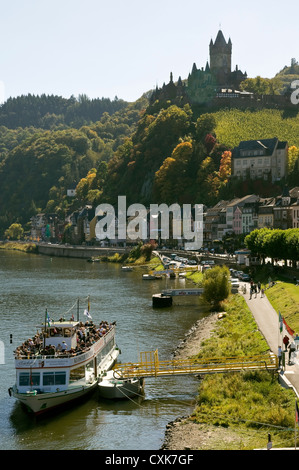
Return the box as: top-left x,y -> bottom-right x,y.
0,84 -> 299,234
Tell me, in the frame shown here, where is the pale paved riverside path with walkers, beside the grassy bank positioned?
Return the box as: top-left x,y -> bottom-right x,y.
240,283 -> 299,397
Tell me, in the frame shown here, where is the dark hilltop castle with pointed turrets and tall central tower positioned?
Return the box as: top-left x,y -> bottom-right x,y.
150,30 -> 297,112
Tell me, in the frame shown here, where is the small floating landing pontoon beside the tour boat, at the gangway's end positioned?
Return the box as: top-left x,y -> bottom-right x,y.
98,370 -> 144,400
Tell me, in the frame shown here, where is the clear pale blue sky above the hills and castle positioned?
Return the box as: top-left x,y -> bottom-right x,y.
0,0 -> 299,101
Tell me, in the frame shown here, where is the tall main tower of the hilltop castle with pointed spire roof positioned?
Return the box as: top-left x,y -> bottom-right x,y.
210,30 -> 232,86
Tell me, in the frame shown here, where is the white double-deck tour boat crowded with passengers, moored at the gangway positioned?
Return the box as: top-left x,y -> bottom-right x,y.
9,303 -> 119,415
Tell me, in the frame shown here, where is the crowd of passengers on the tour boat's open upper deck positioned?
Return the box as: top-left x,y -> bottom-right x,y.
14,319 -> 115,359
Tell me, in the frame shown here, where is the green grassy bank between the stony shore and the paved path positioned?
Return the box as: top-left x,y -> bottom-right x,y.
190,295 -> 295,450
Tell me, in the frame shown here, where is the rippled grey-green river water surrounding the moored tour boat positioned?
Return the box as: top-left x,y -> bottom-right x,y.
0,250 -> 207,450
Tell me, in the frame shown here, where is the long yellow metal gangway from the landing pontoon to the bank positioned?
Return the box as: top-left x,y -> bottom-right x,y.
114,350 -> 278,378
